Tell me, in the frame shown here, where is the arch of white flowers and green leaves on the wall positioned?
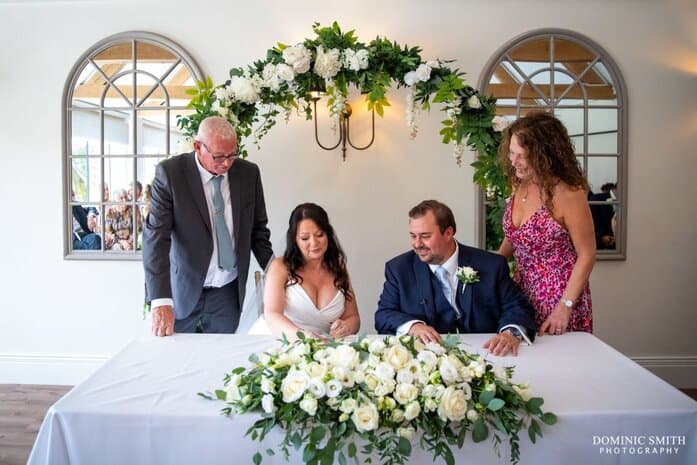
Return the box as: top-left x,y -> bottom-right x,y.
177,22 -> 510,246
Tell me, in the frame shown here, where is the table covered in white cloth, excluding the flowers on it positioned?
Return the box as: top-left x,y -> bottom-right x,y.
28,333 -> 697,465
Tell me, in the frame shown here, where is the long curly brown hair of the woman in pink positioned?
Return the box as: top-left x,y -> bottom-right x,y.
499,111 -> 590,211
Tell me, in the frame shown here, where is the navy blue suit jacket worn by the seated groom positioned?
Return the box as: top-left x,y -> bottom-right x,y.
375,243 -> 535,340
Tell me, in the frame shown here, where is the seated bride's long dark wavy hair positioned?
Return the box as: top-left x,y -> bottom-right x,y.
283,203 -> 353,301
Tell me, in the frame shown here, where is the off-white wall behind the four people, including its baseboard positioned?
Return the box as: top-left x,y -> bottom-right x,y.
0,0 -> 697,388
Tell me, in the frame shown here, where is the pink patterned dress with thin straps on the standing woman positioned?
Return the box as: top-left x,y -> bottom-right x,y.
502,196 -> 593,333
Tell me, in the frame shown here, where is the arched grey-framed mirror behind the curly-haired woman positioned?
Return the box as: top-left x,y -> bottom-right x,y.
479,29 -> 627,260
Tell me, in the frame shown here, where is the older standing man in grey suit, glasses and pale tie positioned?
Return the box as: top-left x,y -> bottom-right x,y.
143,116 -> 273,336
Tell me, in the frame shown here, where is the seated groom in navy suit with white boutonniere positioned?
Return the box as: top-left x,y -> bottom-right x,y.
375,200 -> 535,355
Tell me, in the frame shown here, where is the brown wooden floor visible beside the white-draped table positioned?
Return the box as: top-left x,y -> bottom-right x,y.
0,384 -> 697,465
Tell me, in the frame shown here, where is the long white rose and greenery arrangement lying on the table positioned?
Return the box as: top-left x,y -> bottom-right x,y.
200,333 -> 556,465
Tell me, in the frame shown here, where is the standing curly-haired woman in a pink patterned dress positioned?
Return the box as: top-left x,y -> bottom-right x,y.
499,112 -> 595,335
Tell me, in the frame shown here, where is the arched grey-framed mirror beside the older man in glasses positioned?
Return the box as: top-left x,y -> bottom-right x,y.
63,32 -> 203,259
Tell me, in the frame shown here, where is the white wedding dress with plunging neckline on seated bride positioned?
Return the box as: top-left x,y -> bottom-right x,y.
248,283 -> 346,334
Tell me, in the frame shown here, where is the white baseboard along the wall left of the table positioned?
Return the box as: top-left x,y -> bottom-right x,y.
0,354 -> 108,386
